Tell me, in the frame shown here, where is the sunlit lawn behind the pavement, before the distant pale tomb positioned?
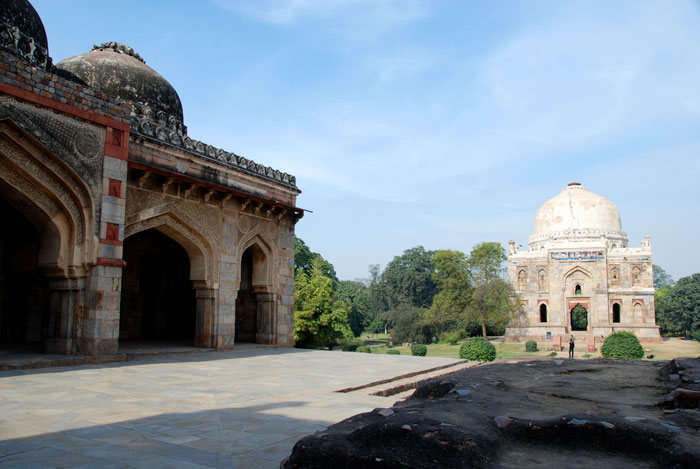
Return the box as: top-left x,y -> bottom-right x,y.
362,334 -> 700,360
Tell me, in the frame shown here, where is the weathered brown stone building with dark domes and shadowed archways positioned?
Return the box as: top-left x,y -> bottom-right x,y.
0,0 -> 303,355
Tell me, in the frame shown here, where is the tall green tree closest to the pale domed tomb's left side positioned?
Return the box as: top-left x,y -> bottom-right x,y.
467,242 -> 519,338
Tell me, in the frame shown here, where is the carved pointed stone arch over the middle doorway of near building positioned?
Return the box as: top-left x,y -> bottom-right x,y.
124,211 -> 215,288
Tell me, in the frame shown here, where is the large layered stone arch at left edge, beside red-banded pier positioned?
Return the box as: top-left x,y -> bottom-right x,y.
0,119 -> 97,278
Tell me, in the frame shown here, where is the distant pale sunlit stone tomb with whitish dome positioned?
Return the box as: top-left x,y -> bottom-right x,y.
506,183 -> 661,343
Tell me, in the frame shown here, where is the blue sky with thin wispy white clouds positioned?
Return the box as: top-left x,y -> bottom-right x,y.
32,0 -> 700,279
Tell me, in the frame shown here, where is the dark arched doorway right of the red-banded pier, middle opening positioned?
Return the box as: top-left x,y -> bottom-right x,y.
119,229 -> 197,345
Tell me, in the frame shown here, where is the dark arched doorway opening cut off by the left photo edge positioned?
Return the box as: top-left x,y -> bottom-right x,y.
0,198 -> 50,352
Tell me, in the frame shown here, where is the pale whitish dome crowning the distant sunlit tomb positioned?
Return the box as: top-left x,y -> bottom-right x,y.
530,183 -> 627,244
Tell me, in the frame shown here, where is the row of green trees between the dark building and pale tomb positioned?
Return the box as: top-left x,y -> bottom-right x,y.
294,238 -> 520,348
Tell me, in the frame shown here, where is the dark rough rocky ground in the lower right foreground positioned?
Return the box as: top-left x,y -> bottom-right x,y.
282,359 -> 700,469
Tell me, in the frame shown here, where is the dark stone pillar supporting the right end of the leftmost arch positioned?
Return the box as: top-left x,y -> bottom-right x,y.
46,278 -> 85,355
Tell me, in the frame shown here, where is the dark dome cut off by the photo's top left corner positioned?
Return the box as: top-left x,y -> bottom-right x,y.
0,0 -> 51,70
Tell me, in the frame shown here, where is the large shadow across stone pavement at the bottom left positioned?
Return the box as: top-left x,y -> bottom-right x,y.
0,401 -> 332,469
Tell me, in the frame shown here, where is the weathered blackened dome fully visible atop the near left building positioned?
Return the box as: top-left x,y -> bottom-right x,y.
56,42 -> 183,123
